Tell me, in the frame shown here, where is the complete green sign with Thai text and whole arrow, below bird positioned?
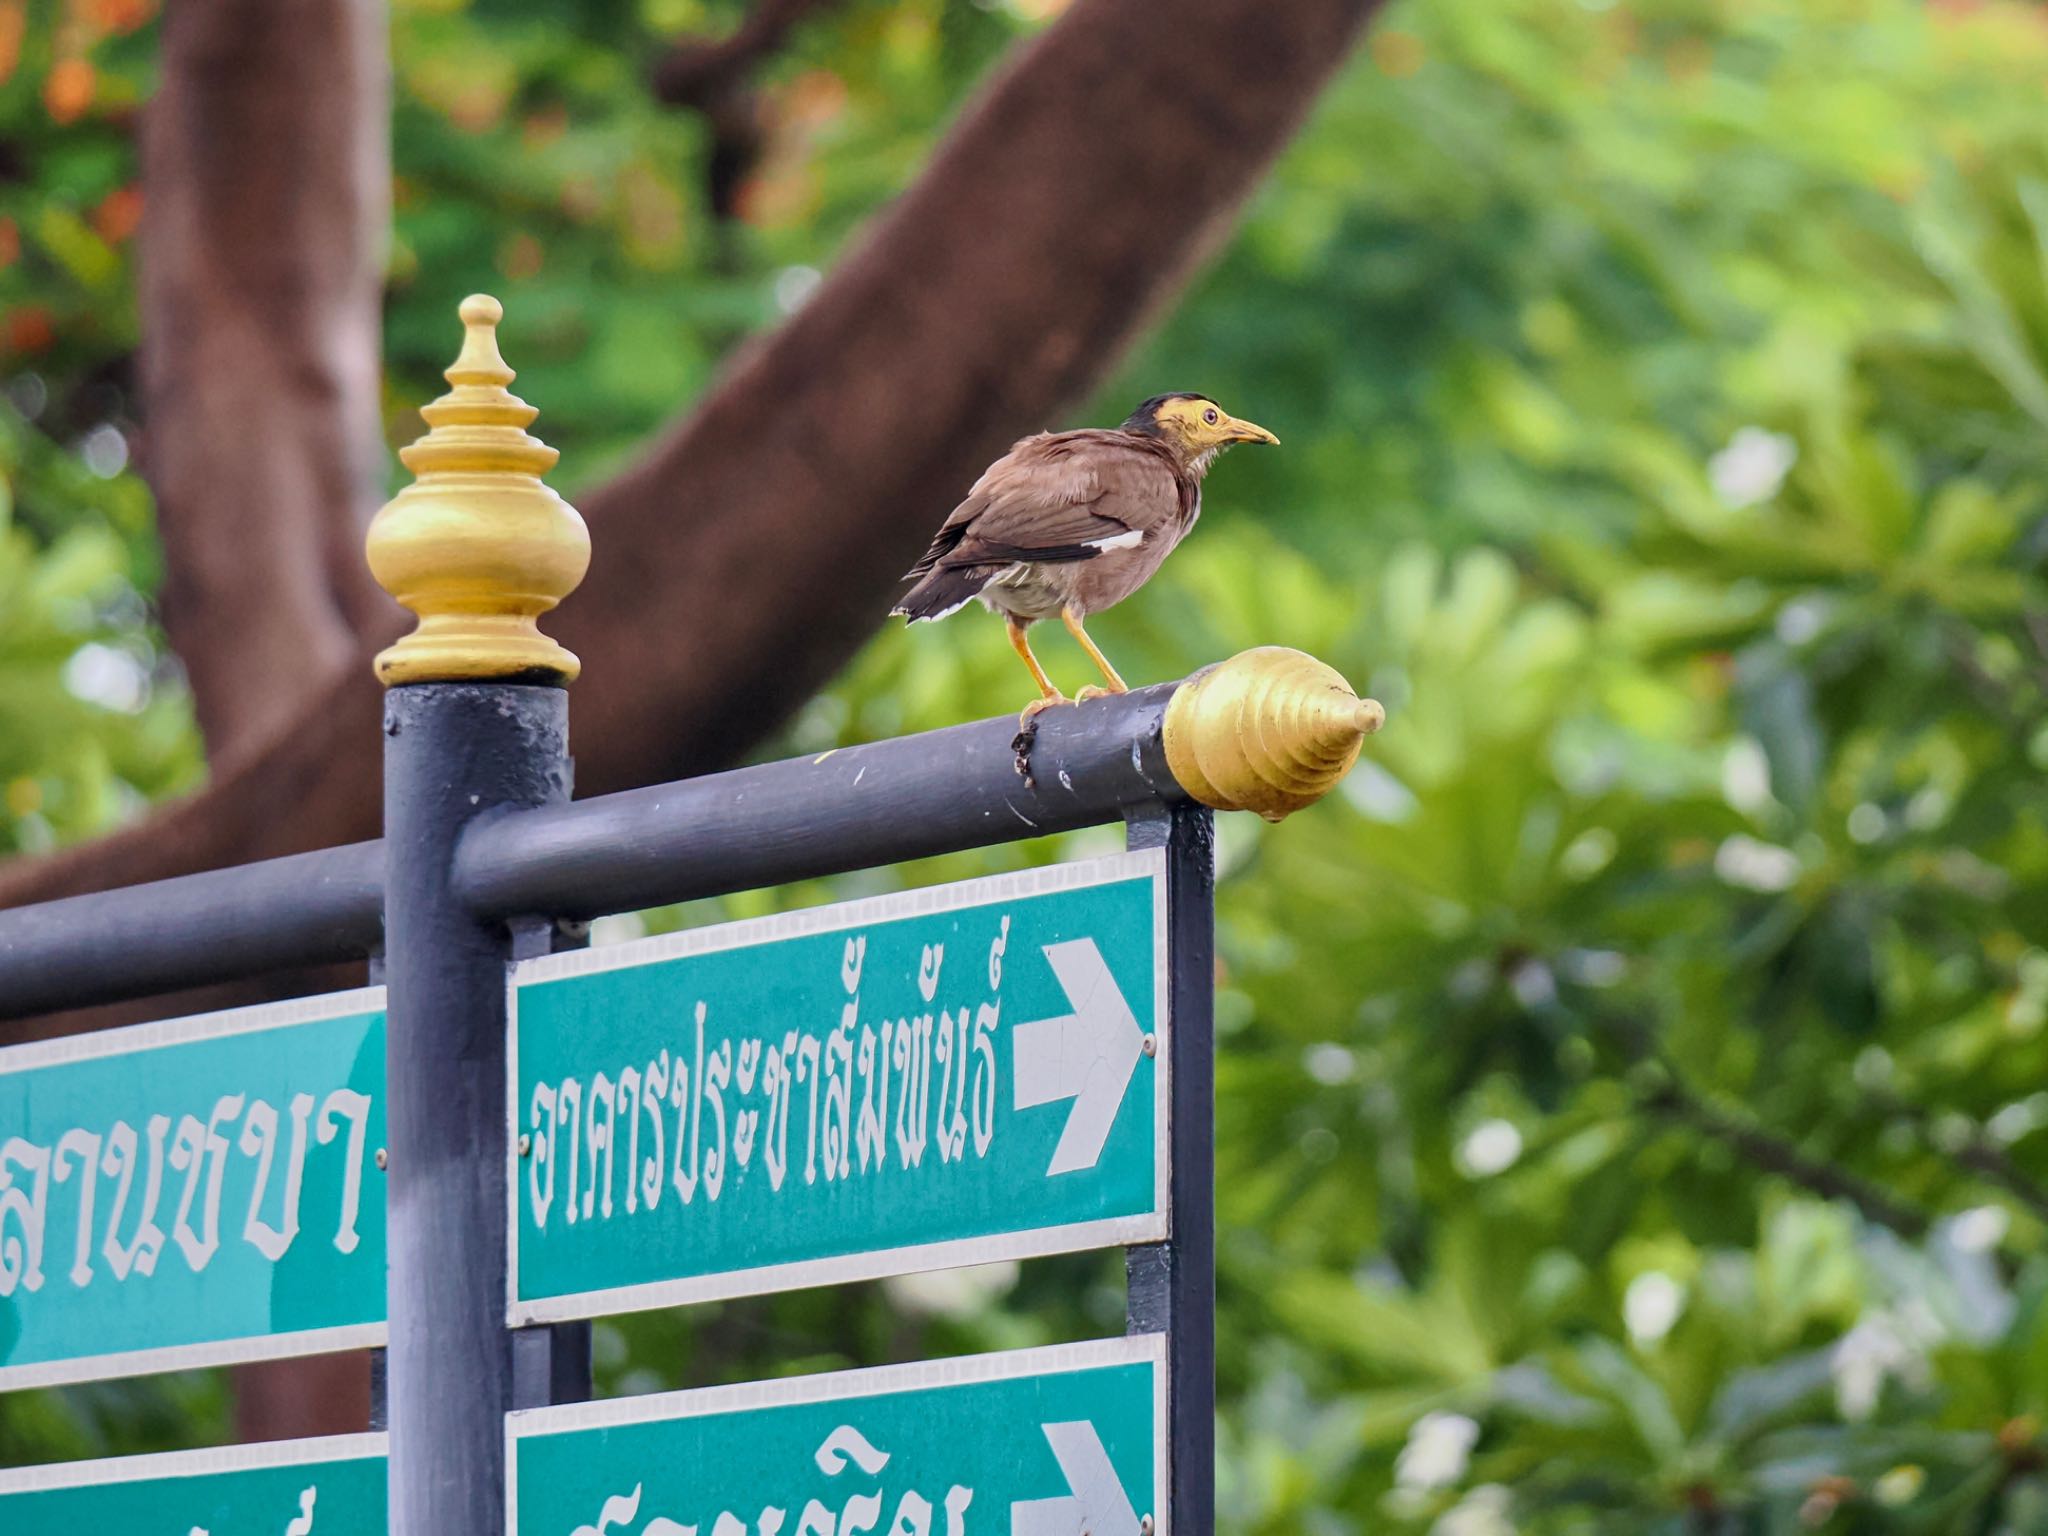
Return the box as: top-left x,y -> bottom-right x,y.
510,850 -> 1167,1325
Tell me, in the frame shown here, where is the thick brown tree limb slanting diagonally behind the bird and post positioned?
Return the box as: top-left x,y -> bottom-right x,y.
0,0 -> 1376,905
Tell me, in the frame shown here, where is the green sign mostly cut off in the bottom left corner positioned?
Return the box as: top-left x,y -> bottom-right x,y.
0,1436 -> 385,1536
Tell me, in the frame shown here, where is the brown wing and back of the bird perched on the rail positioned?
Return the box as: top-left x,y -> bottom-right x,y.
909,430 -> 1182,578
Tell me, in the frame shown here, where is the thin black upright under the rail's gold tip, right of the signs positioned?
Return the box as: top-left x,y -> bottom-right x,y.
1124,803 -> 1217,1536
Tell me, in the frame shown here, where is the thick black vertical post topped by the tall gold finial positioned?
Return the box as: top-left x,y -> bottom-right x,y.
385,682 -> 569,1536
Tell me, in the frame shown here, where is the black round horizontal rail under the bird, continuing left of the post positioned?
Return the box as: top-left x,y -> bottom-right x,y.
0,684 -> 1186,1018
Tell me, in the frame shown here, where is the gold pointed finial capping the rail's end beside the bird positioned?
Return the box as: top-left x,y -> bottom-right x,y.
1165,645 -> 1386,821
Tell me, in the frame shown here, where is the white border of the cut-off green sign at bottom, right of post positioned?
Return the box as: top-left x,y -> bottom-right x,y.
506,1333 -> 1174,1536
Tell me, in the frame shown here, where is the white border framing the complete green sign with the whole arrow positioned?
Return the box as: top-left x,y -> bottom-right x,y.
506,848 -> 1174,1327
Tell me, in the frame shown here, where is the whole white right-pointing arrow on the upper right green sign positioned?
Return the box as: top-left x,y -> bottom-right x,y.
1012,938 -> 1145,1174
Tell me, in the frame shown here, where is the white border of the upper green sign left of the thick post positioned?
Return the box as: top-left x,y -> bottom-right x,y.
0,987 -> 387,1392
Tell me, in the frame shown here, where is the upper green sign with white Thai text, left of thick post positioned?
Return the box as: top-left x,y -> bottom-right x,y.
0,989 -> 385,1392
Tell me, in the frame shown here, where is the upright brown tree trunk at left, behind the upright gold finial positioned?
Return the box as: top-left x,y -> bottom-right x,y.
141,0 -> 395,764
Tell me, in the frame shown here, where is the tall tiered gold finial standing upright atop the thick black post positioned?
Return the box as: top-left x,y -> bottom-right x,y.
367,293 -> 590,688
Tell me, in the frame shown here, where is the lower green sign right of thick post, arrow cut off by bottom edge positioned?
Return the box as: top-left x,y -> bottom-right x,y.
506,1335 -> 1169,1536
